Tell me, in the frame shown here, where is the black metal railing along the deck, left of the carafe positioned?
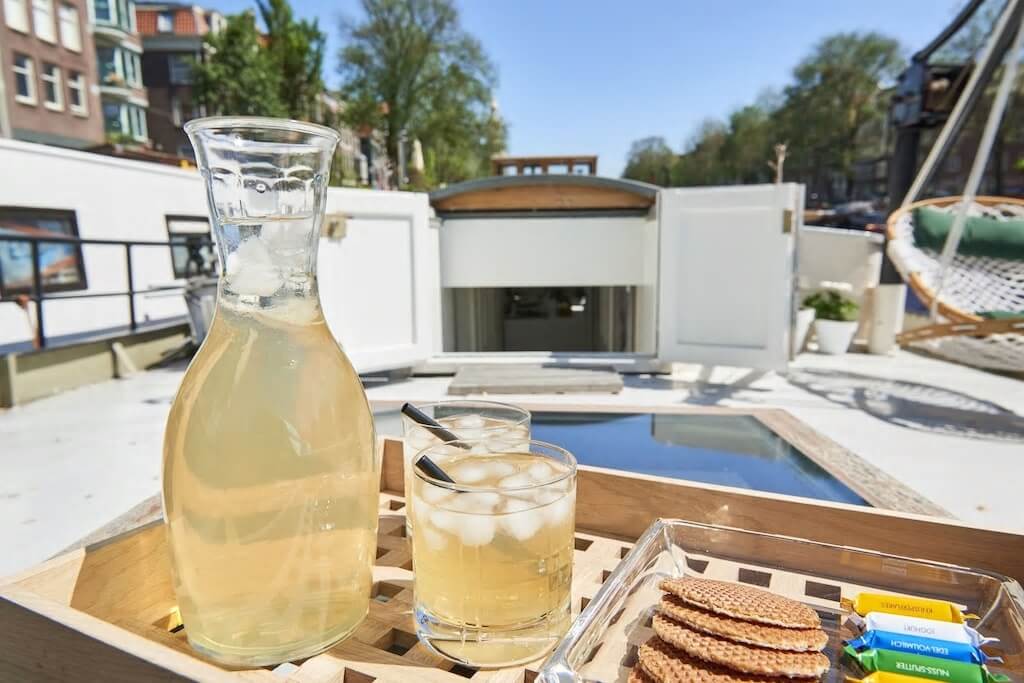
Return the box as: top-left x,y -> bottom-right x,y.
0,233 -> 215,348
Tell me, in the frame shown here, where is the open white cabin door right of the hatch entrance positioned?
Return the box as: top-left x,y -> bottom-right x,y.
657,183 -> 804,370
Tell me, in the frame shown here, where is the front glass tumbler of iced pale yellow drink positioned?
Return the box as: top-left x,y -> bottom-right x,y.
412,452 -> 575,666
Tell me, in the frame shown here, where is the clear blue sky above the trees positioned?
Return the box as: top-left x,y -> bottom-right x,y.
205,0 -> 963,175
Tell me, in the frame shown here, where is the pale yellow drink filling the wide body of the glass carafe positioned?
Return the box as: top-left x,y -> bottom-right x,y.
164,292 -> 378,666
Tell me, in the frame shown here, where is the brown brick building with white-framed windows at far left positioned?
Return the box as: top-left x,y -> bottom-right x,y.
0,0 -> 103,148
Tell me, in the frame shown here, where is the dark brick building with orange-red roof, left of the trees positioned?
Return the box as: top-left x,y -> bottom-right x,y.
135,0 -> 224,157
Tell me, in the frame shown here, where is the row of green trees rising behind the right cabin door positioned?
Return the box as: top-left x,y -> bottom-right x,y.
624,33 -> 903,199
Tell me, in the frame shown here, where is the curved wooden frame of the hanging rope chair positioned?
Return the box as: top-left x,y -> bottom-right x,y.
886,196 -> 1024,346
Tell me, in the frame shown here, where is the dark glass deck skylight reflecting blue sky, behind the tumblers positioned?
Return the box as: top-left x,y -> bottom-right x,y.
531,413 -> 867,505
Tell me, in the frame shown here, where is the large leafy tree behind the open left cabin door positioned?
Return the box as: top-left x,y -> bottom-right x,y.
339,0 -> 505,184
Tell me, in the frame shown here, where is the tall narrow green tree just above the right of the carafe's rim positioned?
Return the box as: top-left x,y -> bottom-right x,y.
256,0 -> 327,121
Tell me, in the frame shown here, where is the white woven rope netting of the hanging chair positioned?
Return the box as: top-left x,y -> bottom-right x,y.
889,200 -> 1024,372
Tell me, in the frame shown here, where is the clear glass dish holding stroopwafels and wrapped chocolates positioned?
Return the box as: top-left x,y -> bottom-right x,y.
537,519 -> 1024,683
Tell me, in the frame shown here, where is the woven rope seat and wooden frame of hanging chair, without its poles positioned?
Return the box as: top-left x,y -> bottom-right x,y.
888,197 -> 1024,371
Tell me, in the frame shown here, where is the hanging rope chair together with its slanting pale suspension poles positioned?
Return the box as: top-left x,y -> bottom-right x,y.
886,0 -> 1024,372
